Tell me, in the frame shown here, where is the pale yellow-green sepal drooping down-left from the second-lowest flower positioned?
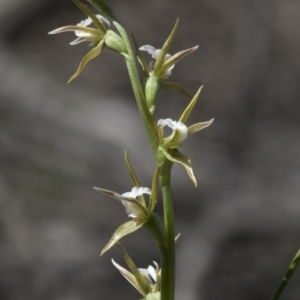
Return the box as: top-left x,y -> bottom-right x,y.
100,219 -> 145,256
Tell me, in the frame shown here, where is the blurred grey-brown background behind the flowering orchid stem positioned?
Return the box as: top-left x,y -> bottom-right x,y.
0,0 -> 300,300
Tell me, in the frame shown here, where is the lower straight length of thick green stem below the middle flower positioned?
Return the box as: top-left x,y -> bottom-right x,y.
160,160 -> 176,300
